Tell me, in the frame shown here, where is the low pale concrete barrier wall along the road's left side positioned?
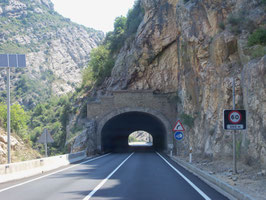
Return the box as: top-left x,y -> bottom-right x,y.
0,151 -> 86,183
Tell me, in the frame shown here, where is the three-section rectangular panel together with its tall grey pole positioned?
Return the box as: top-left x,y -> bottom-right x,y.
0,54 -> 26,164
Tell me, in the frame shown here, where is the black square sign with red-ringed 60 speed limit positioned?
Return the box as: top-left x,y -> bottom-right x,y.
224,110 -> 246,130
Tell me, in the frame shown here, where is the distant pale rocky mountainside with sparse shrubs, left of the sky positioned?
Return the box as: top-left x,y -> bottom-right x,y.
0,0 -> 104,108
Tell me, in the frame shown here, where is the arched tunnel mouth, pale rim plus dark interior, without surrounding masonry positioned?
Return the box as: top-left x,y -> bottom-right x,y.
97,107 -> 171,151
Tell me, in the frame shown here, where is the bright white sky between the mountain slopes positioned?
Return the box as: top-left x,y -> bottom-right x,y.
52,0 -> 135,33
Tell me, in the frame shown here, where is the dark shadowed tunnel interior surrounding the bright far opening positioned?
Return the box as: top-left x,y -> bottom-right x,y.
101,112 -> 167,152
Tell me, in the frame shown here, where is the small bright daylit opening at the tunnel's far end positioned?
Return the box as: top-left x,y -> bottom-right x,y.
128,131 -> 153,147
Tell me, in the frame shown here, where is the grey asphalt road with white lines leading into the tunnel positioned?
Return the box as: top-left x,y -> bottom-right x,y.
0,152 -> 227,200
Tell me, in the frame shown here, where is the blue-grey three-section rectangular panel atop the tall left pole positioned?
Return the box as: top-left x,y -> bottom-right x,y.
0,54 -> 26,67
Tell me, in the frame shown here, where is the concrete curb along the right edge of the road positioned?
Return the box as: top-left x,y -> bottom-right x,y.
169,156 -> 255,200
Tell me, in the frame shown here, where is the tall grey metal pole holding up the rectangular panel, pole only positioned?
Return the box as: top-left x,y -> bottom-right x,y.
7,66 -> 11,164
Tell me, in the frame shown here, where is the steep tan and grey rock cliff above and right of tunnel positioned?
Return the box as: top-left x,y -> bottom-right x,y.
105,0 -> 266,166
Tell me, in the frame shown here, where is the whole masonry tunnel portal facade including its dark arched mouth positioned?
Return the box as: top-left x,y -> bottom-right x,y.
87,90 -> 176,152
